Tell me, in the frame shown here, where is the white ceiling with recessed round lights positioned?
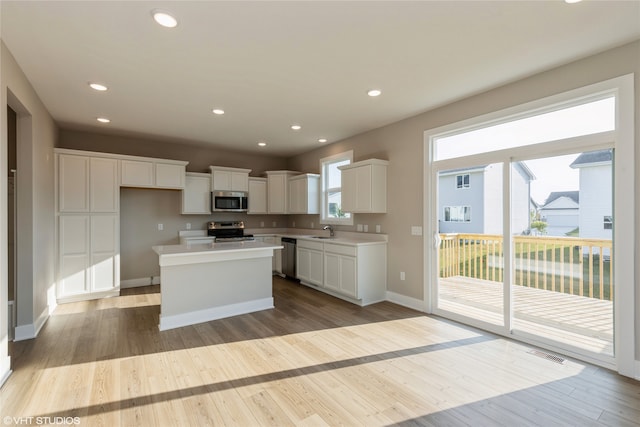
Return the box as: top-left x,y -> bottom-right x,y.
0,0 -> 640,156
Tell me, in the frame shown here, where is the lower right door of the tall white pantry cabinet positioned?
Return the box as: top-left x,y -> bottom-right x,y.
89,215 -> 120,291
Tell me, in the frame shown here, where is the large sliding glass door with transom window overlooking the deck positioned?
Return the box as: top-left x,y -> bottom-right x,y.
425,77 -> 634,372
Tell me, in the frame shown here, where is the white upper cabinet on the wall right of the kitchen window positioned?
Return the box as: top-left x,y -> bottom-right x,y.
339,159 -> 389,213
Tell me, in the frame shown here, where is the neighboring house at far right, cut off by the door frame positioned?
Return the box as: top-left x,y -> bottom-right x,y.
570,150 -> 613,239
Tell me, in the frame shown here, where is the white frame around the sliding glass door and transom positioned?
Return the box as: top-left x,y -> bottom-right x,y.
423,74 -> 638,378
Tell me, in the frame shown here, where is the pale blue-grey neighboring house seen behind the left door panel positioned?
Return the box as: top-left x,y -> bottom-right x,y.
438,163 -> 535,234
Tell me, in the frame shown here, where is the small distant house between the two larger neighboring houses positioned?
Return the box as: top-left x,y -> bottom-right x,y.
540,191 -> 580,236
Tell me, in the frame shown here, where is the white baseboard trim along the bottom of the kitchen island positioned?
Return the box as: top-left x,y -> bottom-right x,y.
158,297 -> 274,331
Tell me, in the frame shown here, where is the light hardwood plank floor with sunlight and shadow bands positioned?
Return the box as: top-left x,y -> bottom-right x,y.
0,278 -> 640,426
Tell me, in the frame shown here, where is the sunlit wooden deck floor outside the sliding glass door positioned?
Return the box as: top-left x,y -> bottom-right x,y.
439,276 -> 613,355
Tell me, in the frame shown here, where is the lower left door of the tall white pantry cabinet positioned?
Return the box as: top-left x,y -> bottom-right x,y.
57,215 -> 90,297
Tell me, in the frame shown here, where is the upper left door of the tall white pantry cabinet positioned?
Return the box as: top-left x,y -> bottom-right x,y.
58,154 -> 89,212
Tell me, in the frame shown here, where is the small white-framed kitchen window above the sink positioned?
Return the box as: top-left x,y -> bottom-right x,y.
320,151 -> 353,225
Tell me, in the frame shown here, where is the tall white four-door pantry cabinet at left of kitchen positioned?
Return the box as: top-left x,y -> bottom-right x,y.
55,149 -> 120,302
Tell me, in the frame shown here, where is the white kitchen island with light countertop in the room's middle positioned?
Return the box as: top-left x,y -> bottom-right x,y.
153,241 -> 282,331
